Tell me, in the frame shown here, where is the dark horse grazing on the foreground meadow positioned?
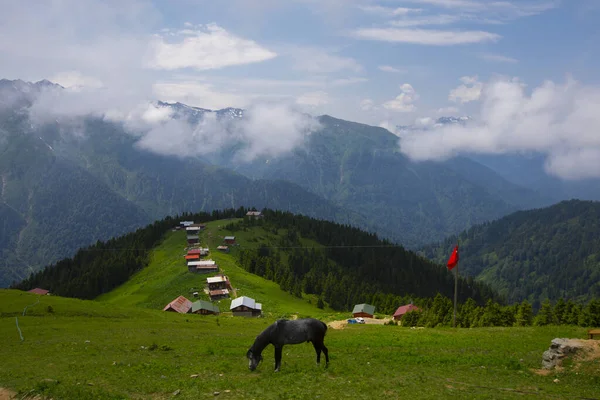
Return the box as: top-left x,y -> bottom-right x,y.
246,318 -> 329,372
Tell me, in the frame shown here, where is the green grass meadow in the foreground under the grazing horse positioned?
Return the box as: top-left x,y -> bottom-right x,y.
0,290 -> 600,399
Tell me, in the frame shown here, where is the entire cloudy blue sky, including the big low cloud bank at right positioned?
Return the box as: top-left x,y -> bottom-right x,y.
0,0 -> 600,176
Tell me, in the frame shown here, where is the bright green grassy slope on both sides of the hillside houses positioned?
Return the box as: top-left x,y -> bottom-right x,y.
97,219 -> 330,316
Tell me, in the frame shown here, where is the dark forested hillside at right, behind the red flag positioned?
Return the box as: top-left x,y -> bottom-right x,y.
424,200 -> 600,308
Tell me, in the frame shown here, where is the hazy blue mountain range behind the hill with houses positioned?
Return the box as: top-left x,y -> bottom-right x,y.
0,80 -> 596,287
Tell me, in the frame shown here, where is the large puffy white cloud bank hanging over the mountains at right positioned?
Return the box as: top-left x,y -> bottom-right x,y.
401,78 -> 600,179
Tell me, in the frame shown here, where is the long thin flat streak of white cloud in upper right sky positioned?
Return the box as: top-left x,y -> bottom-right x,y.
351,28 -> 501,46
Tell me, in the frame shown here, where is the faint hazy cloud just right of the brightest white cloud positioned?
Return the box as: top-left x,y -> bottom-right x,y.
288,47 -> 363,74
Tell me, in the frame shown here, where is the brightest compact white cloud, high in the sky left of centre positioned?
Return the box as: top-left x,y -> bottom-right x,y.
147,23 -> 277,70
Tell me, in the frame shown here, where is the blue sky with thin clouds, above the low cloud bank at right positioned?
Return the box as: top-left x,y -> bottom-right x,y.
0,0 -> 600,124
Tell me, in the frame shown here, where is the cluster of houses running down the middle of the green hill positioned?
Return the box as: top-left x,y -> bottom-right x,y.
163,219 -> 262,317
